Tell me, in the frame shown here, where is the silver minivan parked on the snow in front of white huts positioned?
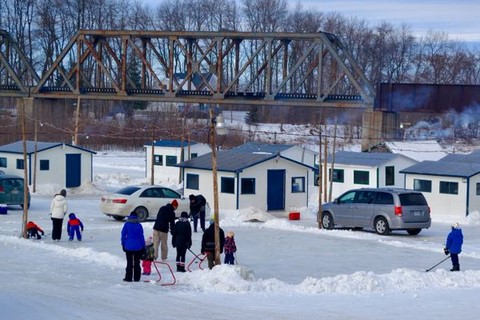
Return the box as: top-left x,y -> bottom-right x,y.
320,188 -> 432,235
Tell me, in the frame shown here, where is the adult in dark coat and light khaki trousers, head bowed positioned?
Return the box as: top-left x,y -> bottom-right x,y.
153,199 -> 178,262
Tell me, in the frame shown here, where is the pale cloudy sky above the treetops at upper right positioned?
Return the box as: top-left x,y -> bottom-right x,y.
143,0 -> 480,42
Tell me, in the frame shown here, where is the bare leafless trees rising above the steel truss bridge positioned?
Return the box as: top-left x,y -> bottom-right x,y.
0,0 -> 480,84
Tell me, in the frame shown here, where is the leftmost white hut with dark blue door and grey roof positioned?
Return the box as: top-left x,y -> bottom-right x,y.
0,141 -> 96,189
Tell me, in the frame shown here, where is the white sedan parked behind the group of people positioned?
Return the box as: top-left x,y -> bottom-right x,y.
100,185 -> 190,221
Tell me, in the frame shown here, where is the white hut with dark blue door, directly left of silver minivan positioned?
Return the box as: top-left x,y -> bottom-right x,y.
174,143 -> 315,211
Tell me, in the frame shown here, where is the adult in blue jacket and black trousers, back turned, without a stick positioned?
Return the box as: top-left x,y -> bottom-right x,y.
121,212 -> 145,282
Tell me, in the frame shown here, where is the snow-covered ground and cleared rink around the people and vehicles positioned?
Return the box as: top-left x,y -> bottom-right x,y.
0,152 -> 480,320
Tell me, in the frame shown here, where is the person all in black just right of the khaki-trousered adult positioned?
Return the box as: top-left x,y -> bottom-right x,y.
172,211 -> 192,272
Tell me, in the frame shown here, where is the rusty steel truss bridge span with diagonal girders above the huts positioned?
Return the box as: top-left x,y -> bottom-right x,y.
0,30 -> 375,108
